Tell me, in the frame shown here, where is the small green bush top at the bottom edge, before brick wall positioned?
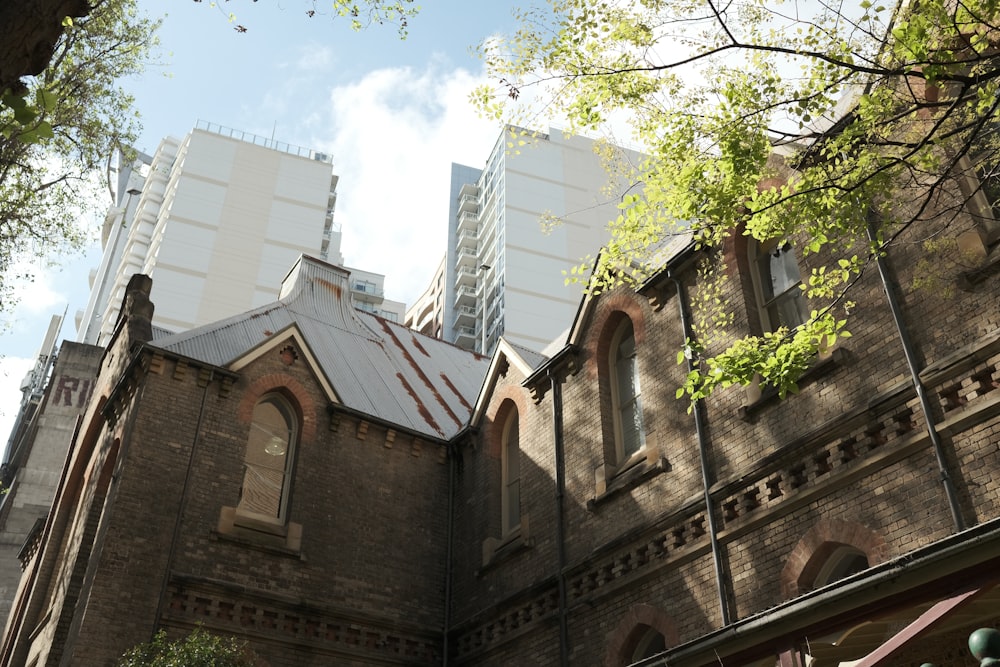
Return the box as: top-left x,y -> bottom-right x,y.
118,627 -> 257,667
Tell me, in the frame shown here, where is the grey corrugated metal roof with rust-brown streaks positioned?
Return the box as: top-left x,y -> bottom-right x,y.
151,257 -> 488,439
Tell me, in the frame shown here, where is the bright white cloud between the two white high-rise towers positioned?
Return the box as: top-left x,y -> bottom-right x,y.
310,65 -> 501,305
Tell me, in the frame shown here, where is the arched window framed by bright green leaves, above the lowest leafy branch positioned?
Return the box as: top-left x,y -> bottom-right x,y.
749,240 -> 809,331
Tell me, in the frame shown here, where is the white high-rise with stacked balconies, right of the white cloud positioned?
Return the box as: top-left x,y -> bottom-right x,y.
443,128 -> 638,354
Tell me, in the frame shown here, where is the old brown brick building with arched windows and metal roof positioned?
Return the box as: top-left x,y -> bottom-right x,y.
2,183 -> 1000,667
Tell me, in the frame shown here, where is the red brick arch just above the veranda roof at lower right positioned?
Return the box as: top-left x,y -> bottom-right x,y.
781,519 -> 889,600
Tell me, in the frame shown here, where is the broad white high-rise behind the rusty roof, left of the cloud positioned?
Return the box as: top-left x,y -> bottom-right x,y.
77,122 -> 404,345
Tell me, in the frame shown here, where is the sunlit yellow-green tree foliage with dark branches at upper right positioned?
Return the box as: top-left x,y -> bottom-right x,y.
474,0 -> 1000,398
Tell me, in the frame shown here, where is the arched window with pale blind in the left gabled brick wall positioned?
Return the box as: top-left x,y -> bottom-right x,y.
238,394 -> 298,520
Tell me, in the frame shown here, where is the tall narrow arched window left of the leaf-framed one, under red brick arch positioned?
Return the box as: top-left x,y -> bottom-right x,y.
610,317 -> 646,463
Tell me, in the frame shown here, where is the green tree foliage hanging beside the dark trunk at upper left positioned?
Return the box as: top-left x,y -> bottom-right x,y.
0,0 -> 157,307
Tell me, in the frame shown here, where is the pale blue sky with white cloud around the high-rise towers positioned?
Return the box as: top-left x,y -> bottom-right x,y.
0,0 -> 528,446
